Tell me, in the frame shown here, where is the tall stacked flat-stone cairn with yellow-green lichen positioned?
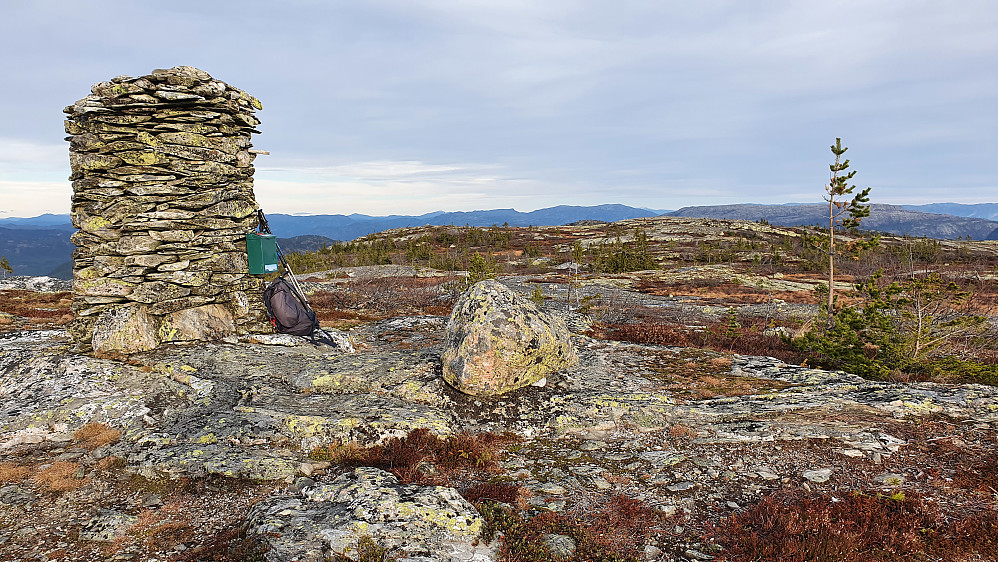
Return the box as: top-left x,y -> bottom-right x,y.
65,66 -> 269,353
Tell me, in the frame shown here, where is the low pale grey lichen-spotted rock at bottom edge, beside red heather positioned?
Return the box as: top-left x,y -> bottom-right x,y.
242,467 -> 496,562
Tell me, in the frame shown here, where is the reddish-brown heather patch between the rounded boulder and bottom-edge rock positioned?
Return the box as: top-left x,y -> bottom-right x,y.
309,429 -> 665,562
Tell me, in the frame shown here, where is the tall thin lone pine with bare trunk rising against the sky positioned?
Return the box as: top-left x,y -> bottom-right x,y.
824,138 -> 870,330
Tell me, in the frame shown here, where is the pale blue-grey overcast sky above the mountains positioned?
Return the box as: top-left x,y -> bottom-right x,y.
0,0 -> 998,217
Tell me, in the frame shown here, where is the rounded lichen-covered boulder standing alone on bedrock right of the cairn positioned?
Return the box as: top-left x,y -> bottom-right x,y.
441,279 -> 576,396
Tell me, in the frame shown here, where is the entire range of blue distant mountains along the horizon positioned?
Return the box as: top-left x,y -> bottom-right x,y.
0,203 -> 998,279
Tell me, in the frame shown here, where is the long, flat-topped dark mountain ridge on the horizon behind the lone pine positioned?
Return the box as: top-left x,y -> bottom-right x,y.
666,204 -> 998,240
